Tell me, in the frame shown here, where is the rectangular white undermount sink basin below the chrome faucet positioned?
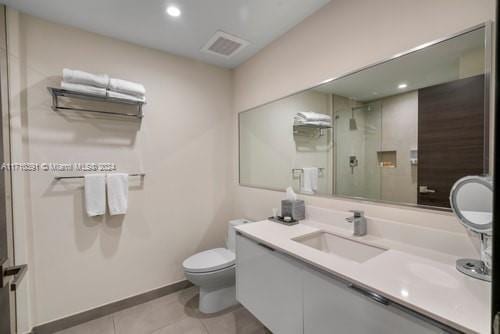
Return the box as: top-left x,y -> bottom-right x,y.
293,232 -> 386,263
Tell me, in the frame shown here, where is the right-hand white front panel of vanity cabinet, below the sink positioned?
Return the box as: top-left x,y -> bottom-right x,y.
302,268 -> 445,334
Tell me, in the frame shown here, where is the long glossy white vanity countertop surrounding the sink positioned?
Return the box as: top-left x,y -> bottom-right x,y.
236,220 -> 491,333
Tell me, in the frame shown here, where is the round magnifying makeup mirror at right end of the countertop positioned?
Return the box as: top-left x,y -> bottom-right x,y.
450,176 -> 493,234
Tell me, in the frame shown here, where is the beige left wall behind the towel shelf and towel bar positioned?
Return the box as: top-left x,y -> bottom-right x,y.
8,10 -> 234,329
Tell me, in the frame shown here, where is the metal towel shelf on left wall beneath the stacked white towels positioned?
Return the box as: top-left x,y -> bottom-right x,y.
47,87 -> 146,119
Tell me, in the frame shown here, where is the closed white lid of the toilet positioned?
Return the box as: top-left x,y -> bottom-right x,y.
182,248 -> 236,273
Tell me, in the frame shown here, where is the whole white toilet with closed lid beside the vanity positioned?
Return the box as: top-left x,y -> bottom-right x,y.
182,219 -> 250,313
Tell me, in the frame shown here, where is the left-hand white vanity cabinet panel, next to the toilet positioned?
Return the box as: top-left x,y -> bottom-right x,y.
236,235 -> 303,334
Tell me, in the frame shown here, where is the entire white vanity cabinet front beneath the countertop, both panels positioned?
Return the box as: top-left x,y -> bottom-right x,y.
236,235 -> 454,334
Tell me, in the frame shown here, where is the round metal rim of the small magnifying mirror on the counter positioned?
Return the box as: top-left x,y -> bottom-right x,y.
450,176 -> 493,235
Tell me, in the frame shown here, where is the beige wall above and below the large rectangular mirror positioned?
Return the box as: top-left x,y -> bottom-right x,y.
234,0 -> 495,233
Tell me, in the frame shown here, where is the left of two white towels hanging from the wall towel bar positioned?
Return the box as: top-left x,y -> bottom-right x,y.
84,174 -> 106,217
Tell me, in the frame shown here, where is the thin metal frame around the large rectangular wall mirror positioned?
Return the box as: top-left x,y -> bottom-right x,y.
238,21 -> 495,213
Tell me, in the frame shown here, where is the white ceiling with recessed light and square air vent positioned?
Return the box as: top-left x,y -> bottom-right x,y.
0,0 -> 330,68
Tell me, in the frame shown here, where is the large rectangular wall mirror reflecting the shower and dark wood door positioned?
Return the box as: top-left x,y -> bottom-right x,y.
239,24 -> 491,208
